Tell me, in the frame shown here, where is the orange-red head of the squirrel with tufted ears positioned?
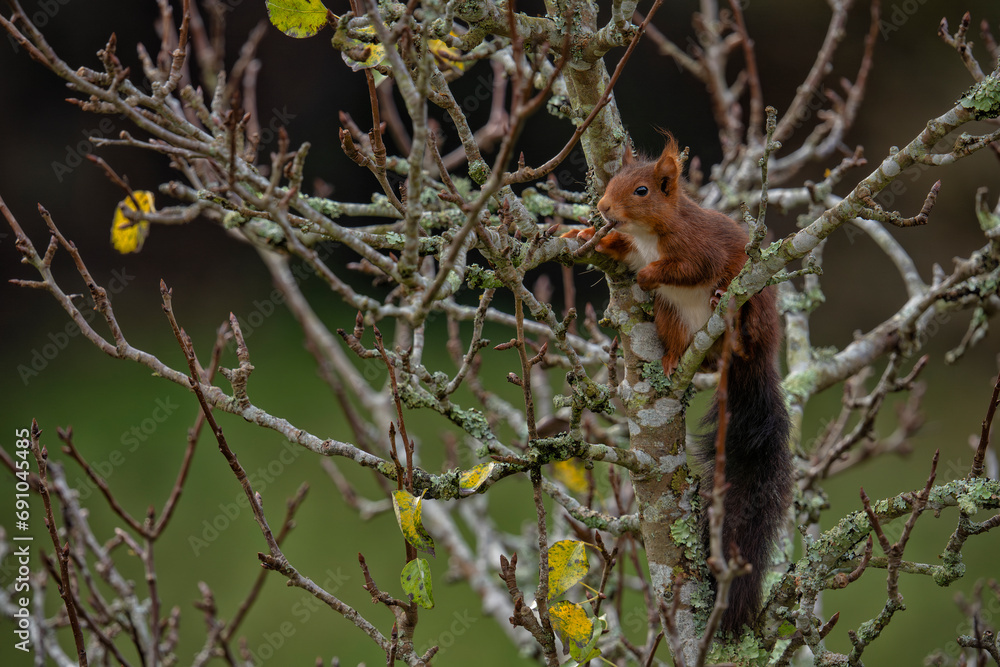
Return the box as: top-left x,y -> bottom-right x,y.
597,132 -> 681,233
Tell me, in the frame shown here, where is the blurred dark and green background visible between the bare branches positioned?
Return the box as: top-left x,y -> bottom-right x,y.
0,0 -> 1000,665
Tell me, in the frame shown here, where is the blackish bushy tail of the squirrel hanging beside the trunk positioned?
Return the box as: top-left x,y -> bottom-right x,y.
698,354 -> 792,632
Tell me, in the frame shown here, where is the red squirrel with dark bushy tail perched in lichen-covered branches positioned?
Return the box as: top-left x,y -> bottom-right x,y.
564,134 -> 792,632
